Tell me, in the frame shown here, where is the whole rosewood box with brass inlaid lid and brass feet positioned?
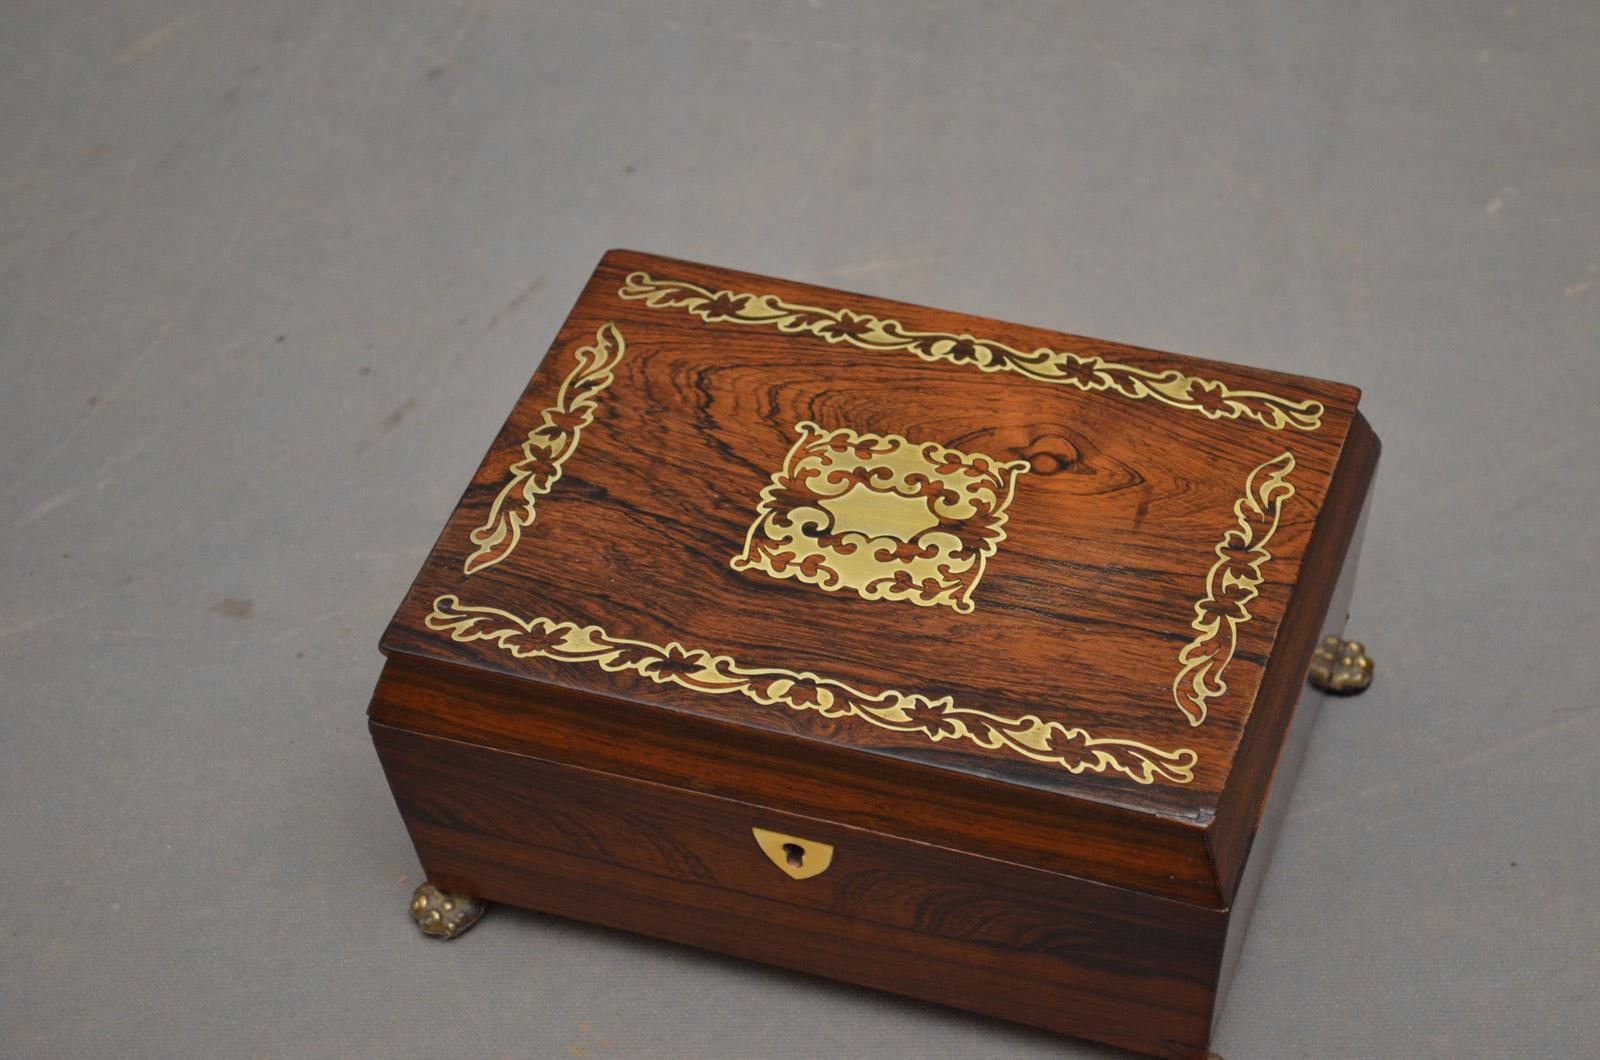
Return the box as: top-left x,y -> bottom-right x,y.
370,250 -> 1379,1057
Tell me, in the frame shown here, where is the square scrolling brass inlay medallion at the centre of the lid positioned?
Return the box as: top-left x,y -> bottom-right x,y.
731,423 -> 1029,615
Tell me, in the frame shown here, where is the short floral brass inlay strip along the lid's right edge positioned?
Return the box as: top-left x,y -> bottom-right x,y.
1173,453 -> 1294,725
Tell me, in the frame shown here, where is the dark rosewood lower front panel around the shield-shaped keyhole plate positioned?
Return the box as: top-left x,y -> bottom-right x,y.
373,724 -> 1227,1055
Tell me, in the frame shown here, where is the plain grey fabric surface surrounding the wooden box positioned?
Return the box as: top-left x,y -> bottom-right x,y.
0,0 -> 1600,1060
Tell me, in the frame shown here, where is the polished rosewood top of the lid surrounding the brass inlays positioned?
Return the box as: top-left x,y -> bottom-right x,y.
384,251 -> 1358,829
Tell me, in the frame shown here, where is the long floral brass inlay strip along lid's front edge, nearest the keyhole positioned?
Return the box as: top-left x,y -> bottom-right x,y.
426,594 -> 1198,785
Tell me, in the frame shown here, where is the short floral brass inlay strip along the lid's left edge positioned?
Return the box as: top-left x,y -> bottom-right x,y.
462,323 -> 627,575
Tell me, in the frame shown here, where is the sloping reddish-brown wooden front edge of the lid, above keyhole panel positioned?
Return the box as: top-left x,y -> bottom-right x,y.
370,658 -> 1226,905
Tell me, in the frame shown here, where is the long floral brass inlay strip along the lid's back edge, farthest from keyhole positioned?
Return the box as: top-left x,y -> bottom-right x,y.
618,272 -> 1325,431
